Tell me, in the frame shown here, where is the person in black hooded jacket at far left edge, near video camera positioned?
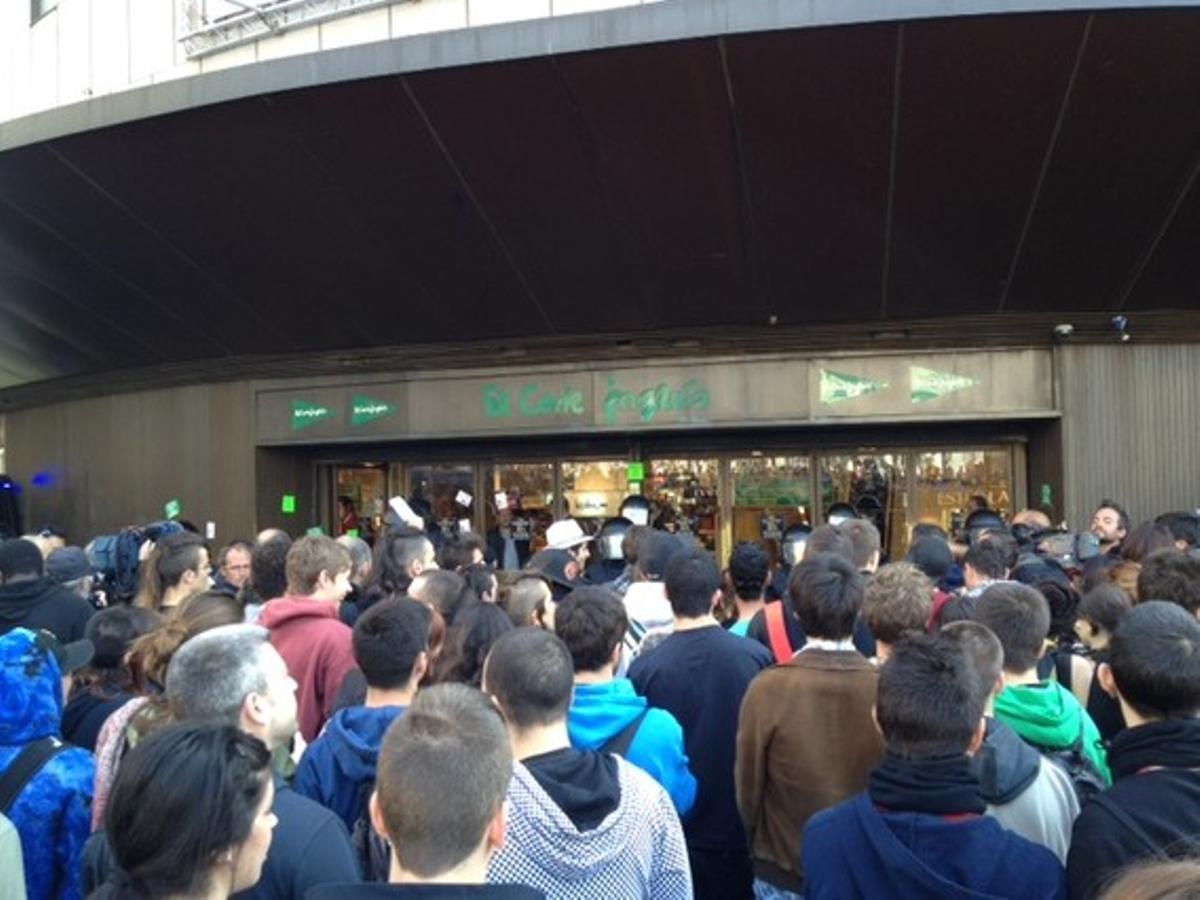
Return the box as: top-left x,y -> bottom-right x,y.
0,538 -> 96,643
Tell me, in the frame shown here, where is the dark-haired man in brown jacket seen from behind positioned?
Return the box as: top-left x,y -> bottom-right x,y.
737,553 -> 883,900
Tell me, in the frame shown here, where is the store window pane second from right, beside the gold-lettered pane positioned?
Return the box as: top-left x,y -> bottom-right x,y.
820,452 -> 908,559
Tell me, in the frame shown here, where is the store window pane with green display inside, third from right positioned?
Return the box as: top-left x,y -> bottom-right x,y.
730,456 -> 812,563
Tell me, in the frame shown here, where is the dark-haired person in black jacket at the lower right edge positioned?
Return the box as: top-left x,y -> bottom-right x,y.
1067,601 -> 1200,900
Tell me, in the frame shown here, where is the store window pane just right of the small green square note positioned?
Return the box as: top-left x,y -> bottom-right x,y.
642,460 -> 721,552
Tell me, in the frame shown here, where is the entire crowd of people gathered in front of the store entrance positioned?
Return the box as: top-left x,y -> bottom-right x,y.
0,500 -> 1200,900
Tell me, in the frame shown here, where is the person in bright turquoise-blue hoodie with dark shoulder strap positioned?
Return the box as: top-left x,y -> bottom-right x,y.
554,586 -> 696,818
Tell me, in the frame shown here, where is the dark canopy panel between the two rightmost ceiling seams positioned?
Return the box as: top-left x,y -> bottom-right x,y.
1006,10 -> 1200,310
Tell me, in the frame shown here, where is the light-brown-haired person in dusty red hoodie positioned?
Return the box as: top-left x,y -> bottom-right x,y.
259,535 -> 355,744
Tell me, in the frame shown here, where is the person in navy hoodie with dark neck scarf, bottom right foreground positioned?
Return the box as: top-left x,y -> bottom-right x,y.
803,635 -> 1067,900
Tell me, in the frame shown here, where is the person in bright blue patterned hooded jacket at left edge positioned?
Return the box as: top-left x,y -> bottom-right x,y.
0,628 -> 96,900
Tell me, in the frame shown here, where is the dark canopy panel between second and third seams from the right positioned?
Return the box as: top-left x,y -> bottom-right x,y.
888,16 -> 1084,317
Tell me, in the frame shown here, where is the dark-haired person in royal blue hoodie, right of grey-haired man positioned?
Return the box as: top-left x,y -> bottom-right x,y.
292,598 -> 432,833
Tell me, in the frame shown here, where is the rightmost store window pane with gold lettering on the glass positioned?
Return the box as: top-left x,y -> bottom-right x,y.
913,449 -> 1013,533
